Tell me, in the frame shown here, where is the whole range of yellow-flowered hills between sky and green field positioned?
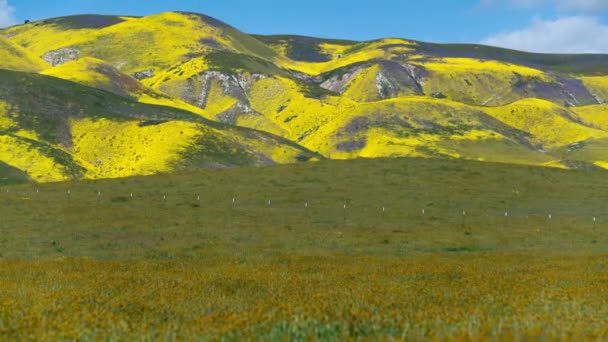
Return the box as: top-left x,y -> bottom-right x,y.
0,12 -> 608,182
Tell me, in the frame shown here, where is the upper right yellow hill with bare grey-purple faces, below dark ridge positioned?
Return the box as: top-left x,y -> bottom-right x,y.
316,56 -> 598,106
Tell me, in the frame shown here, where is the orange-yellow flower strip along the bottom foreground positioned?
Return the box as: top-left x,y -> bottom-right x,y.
0,255 -> 608,340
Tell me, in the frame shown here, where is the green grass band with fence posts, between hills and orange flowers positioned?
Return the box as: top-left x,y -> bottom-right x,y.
0,159 -> 608,259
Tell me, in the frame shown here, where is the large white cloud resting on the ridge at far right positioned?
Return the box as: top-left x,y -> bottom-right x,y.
481,16 -> 608,53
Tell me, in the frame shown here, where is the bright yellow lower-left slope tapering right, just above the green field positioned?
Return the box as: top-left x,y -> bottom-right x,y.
71,119 -> 312,178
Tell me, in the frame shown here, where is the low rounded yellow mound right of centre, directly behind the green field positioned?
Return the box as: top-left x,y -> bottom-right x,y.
294,97 -> 551,164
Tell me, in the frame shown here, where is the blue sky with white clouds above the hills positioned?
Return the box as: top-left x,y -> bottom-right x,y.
0,0 -> 608,53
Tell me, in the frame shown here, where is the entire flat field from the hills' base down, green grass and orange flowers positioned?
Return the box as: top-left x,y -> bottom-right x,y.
0,159 -> 608,340
